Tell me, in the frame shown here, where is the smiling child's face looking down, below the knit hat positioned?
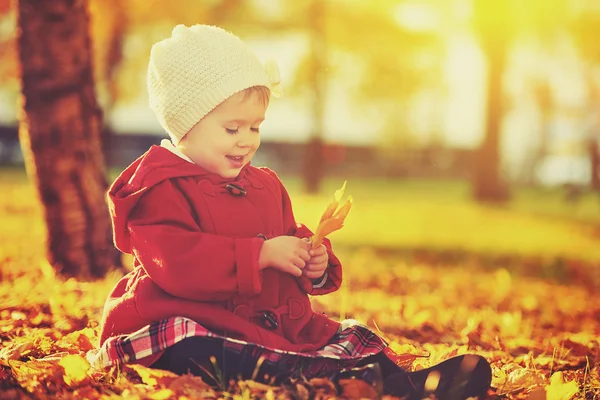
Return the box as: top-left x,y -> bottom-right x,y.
178,92 -> 267,178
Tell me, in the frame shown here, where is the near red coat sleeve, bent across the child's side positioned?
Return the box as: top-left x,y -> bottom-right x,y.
128,181 -> 263,301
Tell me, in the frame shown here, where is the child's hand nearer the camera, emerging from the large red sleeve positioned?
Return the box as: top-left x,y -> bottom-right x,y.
258,236 -> 311,276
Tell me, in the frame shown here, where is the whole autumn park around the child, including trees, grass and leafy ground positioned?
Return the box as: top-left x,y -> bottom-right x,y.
0,0 -> 600,399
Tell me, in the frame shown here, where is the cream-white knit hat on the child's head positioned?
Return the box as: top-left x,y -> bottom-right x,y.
148,25 -> 281,145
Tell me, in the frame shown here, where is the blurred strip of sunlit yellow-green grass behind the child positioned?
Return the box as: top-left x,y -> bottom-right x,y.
0,169 -> 600,262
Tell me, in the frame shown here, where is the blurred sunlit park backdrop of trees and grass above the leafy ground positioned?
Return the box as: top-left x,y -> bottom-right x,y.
0,0 -> 600,284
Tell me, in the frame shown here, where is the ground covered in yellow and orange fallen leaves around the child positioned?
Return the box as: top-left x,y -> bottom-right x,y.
0,170 -> 600,399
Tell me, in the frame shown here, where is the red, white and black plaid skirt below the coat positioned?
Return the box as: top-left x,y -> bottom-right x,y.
87,317 -> 388,378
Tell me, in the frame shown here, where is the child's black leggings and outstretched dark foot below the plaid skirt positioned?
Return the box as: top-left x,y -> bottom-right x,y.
152,337 -> 492,399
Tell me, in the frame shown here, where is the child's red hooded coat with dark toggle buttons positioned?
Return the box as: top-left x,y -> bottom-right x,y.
100,146 -> 342,364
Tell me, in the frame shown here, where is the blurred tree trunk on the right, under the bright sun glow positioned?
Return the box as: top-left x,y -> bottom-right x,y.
473,0 -> 509,202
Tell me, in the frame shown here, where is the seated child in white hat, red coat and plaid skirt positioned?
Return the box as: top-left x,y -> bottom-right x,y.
89,25 -> 491,398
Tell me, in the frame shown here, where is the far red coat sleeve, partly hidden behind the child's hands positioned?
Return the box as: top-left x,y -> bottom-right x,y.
269,171 -> 342,296
